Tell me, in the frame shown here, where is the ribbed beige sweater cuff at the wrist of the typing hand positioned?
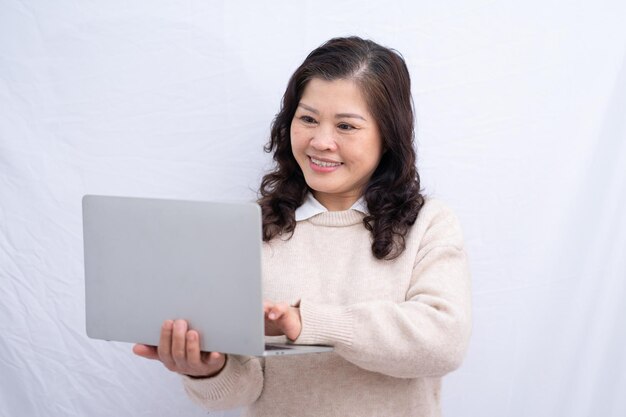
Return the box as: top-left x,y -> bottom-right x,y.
293,299 -> 353,347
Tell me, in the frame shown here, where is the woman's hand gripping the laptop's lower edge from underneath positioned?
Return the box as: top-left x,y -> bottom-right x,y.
133,320 -> 226,378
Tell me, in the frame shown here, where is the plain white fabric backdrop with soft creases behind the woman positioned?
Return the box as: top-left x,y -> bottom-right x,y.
0,0 -> 626,417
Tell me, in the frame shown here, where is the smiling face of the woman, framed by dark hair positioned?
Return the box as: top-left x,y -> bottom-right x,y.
291,78 -> 383,211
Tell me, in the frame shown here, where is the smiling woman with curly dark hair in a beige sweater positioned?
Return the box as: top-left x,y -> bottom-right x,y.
134,37 -> 470,416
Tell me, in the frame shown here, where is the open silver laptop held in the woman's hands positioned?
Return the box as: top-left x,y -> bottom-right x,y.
82,195 -> 332,356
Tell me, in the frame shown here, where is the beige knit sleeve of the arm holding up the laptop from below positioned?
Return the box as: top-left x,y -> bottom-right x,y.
182,355 -> 263,411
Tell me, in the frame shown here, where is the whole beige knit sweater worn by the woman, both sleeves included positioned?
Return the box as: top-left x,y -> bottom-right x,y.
183,200 -> 471,417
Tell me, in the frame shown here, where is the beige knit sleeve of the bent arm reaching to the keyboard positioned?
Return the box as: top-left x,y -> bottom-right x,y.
294,204 -> 471,378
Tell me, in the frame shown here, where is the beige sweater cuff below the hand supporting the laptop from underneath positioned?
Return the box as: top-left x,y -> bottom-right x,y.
181,355 -> 244,401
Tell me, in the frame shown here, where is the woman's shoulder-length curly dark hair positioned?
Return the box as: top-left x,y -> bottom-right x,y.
258,37 -> 424,259
